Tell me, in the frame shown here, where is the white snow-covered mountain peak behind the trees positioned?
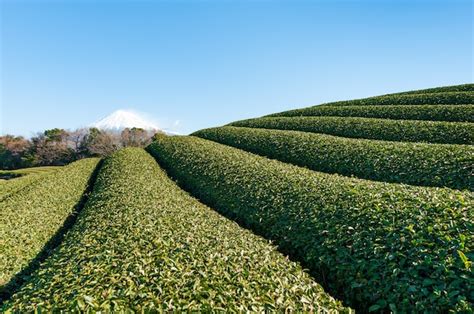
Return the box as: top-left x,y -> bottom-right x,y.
91,109 -> 160,131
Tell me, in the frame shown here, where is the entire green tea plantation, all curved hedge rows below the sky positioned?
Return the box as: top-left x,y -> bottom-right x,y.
0,84 -> 474,313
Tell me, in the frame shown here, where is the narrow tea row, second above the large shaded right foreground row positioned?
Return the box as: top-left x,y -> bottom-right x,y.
229,117 -> 474,144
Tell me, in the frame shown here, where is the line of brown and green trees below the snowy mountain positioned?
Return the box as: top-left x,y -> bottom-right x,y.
0,128 -> 162,169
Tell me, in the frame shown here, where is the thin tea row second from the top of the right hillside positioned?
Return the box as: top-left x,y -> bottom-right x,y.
314,91 -> 474,106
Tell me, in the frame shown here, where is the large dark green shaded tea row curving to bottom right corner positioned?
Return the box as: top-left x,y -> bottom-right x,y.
149,137 -> 474,312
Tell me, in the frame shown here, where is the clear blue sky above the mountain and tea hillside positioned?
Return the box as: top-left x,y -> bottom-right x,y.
0,0 -> 473,136
